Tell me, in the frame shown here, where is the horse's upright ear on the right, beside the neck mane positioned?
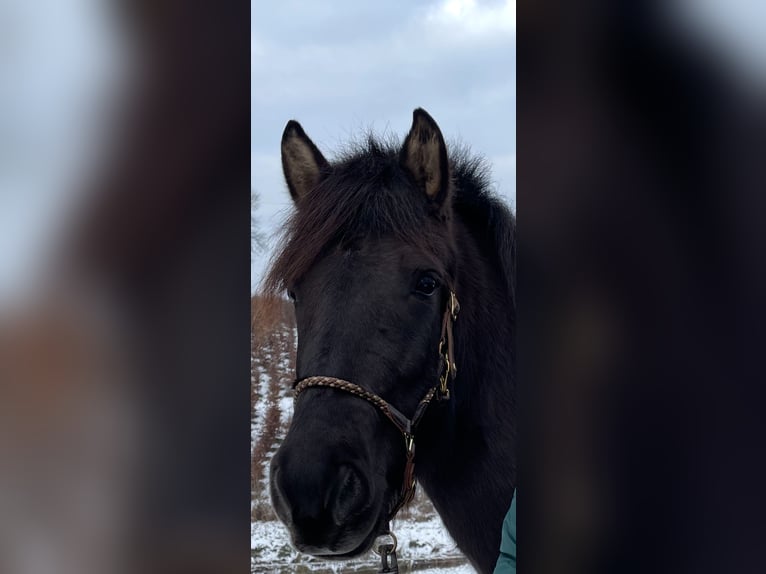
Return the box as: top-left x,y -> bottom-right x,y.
400,108 -> 449,204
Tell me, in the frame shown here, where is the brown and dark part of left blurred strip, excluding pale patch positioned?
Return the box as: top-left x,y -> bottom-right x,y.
0,0 -> 250,574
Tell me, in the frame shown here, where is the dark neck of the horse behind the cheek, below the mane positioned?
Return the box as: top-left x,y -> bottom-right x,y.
416,218 -> 516,571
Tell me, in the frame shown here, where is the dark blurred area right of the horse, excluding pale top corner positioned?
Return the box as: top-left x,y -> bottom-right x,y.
517,1 -> 766,573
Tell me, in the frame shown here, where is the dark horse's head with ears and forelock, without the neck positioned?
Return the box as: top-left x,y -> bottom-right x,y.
267,109 -> 455,557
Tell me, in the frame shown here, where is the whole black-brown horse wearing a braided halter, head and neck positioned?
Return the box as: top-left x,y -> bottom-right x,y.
264,108 -> 517,572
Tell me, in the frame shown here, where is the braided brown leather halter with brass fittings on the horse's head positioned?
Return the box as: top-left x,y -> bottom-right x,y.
294,290 -> 460,520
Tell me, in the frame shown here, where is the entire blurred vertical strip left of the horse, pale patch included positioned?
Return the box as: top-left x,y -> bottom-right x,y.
0,0 -> 250,574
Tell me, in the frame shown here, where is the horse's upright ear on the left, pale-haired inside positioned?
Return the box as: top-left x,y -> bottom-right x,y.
282,120 -> 329,204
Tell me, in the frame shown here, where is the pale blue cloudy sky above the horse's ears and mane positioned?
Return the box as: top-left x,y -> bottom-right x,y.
250,0 -> 516,288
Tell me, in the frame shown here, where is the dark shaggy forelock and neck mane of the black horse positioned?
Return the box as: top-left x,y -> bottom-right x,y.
263,134 -> 516,316
